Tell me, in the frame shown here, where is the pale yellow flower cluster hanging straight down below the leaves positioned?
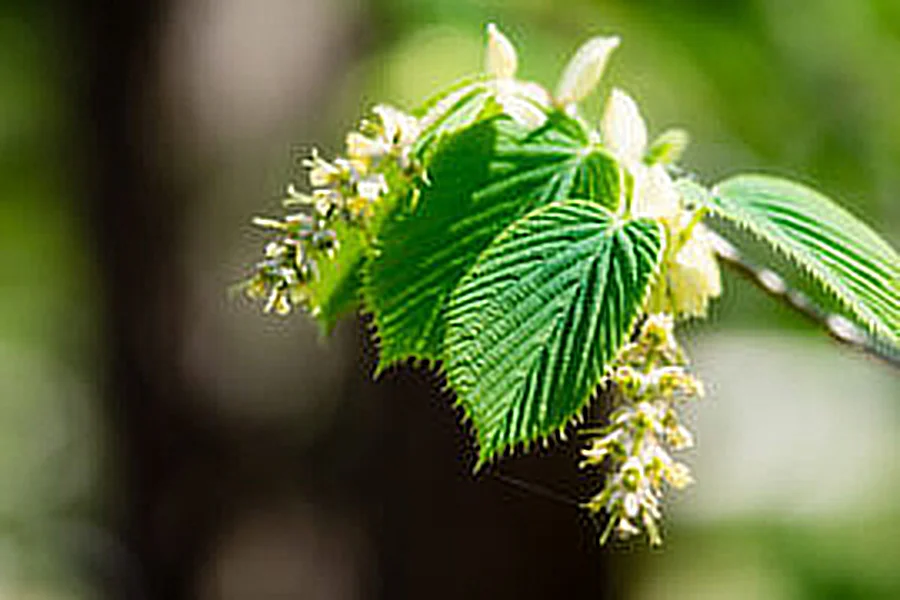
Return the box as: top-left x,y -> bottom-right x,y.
582,314 -> 703,545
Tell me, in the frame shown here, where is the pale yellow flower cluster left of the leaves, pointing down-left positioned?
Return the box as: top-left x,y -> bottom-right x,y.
244,105 -> 419,315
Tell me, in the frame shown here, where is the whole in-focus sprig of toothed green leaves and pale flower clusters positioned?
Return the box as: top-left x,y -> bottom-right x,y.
243,26 -> 900,496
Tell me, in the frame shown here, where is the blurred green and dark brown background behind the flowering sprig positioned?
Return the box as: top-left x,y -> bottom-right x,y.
0,0 -> 900,599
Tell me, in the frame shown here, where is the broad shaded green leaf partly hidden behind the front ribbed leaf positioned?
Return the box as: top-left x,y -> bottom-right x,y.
364,114 -> 620,368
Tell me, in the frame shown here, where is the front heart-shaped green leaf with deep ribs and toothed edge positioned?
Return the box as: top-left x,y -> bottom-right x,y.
446,200 -> 663,463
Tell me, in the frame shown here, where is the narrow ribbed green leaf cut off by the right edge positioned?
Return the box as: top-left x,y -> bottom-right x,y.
709,175 -> 900,345
